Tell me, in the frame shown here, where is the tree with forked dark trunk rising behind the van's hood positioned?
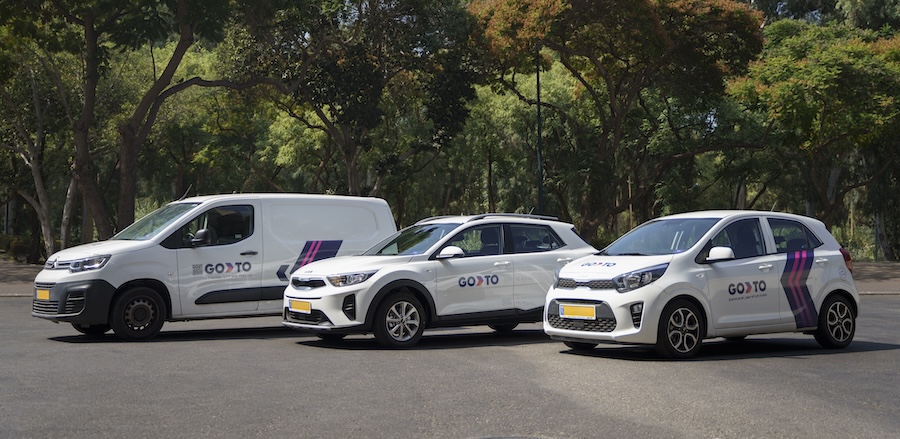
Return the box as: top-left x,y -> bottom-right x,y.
0,0 -> 234,239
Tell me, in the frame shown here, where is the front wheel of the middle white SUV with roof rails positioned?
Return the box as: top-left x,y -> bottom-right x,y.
374,293 -> 425,349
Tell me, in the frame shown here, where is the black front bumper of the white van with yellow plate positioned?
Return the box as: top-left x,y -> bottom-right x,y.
31,279 -> 116,325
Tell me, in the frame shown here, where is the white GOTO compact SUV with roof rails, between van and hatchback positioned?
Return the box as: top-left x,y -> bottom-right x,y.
283,214 -> 597,348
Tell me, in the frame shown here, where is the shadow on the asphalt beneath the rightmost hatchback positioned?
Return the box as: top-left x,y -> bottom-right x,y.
560,338 -> 900,361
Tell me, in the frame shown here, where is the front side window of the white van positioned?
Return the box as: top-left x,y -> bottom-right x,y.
181,206 -> 253,247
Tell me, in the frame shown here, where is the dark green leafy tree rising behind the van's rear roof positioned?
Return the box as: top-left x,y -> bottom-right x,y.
229,0 -> 473,195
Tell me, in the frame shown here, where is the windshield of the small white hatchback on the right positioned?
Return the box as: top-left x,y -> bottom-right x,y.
600,218 -> 719,256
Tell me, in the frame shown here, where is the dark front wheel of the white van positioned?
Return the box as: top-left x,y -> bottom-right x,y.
109,287 -> 166,340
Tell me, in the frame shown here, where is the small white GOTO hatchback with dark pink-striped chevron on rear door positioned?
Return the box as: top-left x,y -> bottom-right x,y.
544,211 -> 859,358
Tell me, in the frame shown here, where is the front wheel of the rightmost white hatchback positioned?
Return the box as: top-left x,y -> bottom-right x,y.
656,299 -> 703,359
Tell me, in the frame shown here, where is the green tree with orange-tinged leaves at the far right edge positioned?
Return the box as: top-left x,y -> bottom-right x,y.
731,20 -> 900,225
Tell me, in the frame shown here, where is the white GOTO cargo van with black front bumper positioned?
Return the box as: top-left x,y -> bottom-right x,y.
31,194 -> 397,340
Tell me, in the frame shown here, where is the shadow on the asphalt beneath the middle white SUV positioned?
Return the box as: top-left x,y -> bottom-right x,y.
297,327 -> 555,351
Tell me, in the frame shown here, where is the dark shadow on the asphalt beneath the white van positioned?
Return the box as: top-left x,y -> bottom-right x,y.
50,326 -> 298,343
